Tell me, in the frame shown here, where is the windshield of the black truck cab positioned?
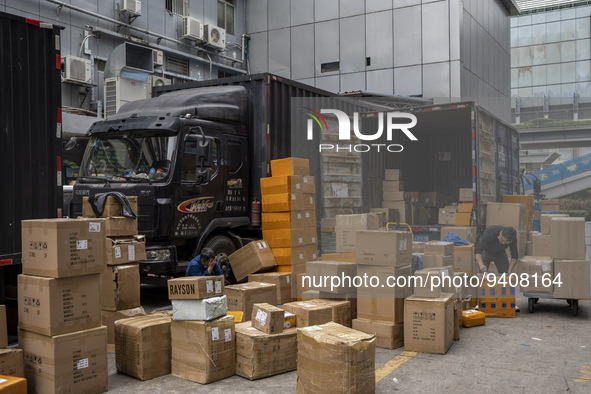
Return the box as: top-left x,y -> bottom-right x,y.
80,133 -> 177,183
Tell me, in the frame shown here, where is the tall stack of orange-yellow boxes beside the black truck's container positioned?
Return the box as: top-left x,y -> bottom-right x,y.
261,158 -> 318,294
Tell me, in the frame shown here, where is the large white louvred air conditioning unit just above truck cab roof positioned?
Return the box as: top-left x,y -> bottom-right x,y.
104,77 -> 152,116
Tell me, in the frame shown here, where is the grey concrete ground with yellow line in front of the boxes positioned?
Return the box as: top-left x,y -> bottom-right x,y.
109,294 -> 591,394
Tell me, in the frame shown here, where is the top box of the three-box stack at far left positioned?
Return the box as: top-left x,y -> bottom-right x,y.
21,219 -> 106,278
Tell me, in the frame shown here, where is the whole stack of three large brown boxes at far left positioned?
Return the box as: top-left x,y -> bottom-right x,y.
18,219 -> 108,393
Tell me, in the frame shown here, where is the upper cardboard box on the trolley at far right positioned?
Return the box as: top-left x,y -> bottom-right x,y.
550,217 -> 587,260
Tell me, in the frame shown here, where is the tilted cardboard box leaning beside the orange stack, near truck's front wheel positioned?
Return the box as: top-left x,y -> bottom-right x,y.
228,240 -> 277,281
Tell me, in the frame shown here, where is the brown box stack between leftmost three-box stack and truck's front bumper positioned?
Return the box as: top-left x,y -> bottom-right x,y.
82,196 -> 146,346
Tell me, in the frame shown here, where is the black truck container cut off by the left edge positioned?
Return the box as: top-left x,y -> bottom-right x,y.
0,13 -> 62,331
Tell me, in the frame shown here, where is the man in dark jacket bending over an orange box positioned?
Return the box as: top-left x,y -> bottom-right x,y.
474,226 -> 519,274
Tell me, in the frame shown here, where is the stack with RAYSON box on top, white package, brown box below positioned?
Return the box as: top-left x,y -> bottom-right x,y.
168,276 -> 236,384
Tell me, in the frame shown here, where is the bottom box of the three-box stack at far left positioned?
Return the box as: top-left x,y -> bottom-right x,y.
18,327 -> 109,394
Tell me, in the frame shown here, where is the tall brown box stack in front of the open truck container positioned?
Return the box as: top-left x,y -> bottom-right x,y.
353,231 -> 412,349
